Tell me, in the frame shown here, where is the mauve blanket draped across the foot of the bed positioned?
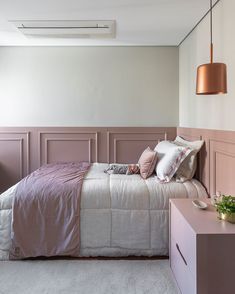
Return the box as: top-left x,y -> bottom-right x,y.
10,162 -> 90,259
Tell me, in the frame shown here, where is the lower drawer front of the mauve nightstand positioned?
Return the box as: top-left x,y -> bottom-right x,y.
170,238 -> 196,294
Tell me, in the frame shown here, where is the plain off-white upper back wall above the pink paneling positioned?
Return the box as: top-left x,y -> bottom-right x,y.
0,47 -> 179,126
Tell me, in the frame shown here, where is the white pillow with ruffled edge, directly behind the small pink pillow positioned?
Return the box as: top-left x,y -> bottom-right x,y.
154,141 -> 192,182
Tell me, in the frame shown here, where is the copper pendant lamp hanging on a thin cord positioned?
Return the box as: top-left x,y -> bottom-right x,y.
196,0 -> 227,95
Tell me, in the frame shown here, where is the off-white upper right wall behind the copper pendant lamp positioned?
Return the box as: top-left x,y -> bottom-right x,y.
179,0 -> 235,130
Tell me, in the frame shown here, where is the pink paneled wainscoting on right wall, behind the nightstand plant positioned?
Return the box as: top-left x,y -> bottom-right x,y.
177,128 -> 235,195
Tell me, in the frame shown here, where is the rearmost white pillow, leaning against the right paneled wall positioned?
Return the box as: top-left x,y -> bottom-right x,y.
174,136 -> 204,182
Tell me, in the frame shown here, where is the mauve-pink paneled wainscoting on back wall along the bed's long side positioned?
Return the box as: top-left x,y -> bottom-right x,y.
0,127 -> 176,191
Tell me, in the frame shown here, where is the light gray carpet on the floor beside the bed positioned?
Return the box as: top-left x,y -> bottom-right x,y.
0,260 -> 180,294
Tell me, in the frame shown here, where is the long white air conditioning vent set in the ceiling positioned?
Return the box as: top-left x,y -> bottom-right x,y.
10,20 -> 116,38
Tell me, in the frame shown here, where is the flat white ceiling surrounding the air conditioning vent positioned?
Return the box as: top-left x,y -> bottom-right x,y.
0,0 -> 216,46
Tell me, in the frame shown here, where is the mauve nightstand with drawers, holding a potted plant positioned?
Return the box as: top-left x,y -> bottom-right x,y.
170,199 -> 235,294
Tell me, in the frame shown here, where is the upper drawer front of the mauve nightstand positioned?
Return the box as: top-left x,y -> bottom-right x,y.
171,202 -> 196,278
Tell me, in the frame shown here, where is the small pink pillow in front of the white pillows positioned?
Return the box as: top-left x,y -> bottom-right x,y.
138,147 -> 157,179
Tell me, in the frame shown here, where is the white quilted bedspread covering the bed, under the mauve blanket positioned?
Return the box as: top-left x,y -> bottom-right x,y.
0,163 -> 207,259
